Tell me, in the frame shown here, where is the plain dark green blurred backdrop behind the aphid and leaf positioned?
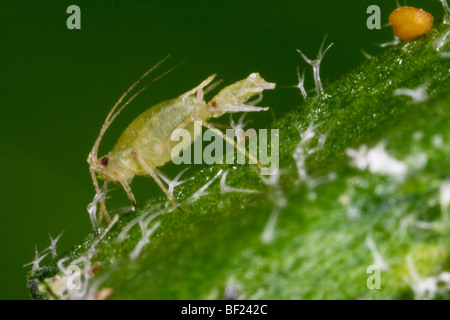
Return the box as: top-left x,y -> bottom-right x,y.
0,0 -> 442,299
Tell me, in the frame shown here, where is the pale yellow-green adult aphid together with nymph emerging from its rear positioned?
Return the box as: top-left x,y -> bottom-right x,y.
87,57 -> 275,222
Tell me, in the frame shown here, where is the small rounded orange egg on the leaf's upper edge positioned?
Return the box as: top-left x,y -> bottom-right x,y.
389,7 -> 433,40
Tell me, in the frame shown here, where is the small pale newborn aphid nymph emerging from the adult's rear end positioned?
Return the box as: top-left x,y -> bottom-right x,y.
208,73 -> 275,118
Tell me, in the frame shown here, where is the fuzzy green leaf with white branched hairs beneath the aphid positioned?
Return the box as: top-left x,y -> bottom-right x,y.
27,24 -> 450,299
